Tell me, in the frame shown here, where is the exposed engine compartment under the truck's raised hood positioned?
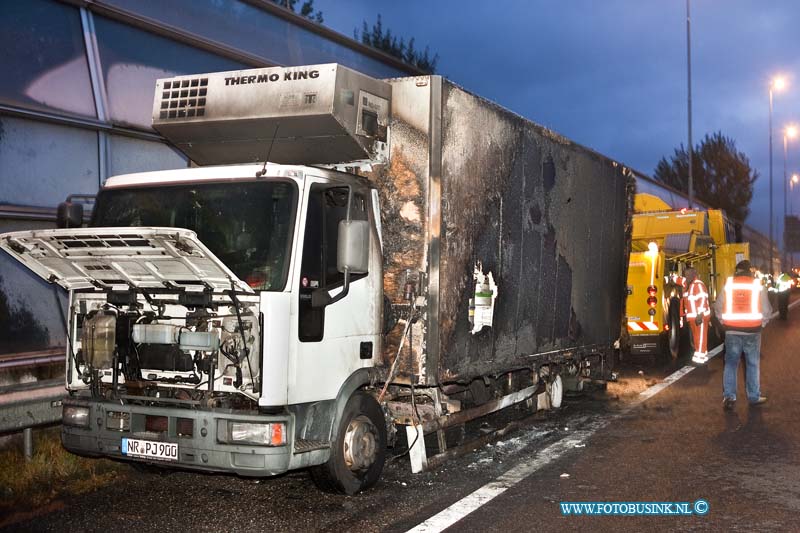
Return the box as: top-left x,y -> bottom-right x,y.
70,293 -> 261,405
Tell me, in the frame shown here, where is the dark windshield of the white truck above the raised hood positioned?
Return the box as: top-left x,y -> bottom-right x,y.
91,181 -> 297,291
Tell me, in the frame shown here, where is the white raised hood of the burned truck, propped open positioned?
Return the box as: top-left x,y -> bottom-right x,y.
0,228 -> 253,293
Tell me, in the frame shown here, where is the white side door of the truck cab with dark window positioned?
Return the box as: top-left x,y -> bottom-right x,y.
289,180 -> 383,404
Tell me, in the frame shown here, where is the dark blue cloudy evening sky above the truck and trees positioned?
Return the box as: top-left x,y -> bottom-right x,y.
315,0 -> 800,240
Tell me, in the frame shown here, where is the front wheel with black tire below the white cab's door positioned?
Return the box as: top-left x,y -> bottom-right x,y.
311,392 -> 386,496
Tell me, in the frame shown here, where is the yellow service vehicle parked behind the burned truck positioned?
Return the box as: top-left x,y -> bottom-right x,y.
626,193 -> 750,358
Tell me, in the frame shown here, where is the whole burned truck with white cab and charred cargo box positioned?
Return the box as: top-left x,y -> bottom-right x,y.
0,64 -> 633,494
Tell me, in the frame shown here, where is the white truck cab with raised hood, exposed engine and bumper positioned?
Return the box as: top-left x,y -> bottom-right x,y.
1,160 -> 386,492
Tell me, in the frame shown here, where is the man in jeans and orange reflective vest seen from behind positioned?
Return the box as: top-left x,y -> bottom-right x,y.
714,261 -> 772,410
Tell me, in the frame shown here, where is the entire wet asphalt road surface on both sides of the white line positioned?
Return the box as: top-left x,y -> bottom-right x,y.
2,302 -> 800,532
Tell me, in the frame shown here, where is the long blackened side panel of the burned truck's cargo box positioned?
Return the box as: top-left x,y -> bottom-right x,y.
438,81 -> 633,382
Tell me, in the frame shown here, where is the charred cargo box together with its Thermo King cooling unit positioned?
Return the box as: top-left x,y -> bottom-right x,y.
153,64 -> 634,385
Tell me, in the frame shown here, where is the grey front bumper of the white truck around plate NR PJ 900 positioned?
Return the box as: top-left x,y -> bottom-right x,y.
61,399 -> 294,476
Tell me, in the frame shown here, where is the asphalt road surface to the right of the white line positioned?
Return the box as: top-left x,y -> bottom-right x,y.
428,302 -> 800,531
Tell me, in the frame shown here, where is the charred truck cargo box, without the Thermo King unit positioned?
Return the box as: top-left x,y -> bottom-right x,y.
368,76 -> 634,385
